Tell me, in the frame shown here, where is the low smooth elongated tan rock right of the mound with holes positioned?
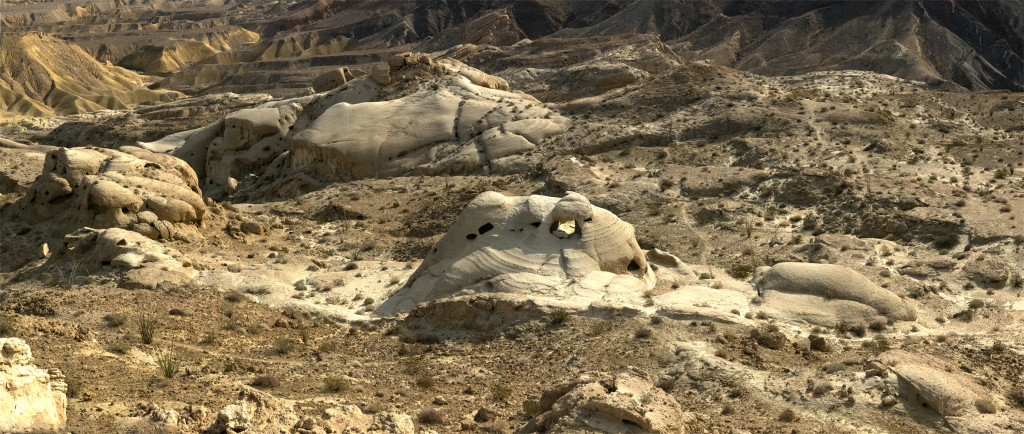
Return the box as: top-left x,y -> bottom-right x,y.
756,262 -> 916,326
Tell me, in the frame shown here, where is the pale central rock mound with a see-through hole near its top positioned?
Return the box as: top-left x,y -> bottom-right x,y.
377,191 -> 655,314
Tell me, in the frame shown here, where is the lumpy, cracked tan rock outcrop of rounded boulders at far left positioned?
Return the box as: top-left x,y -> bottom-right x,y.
22,146 -> 206,240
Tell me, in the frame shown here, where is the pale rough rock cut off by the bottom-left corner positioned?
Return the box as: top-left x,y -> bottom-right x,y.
0,338 -> 68,433
